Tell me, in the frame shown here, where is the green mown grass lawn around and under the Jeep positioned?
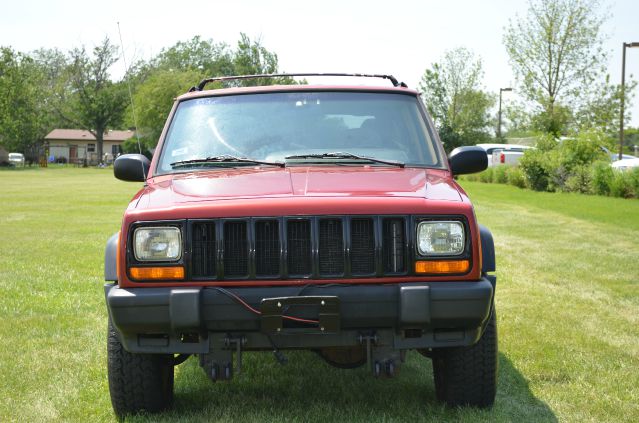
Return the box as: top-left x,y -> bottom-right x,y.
0,168 -> 639,422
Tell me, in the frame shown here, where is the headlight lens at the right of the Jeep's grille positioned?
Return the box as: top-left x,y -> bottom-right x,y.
417,222 -> 465,256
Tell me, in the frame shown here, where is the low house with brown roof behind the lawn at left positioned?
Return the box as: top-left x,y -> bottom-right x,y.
44,129 -> 133,163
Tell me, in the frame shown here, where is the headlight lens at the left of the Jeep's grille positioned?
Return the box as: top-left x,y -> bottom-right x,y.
133,227 -> 182,261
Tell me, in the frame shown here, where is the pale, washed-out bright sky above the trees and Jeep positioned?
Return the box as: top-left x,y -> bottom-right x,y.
0,0 -> 639,126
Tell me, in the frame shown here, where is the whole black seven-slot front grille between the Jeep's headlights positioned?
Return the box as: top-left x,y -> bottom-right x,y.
187,216 -> 410,280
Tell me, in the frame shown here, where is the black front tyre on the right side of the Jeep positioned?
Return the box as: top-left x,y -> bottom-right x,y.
432,311 -> 498,408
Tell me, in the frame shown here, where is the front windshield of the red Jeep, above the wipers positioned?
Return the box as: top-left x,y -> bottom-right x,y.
156,92 -> 443,174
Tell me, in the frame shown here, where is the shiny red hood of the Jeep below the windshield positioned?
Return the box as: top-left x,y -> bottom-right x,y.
137,166 -> 463,209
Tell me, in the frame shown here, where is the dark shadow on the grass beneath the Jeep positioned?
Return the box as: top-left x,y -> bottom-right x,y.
132,351 -> 557,422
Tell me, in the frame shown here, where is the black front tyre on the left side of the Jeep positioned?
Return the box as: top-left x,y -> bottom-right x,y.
107,322 -> 173,418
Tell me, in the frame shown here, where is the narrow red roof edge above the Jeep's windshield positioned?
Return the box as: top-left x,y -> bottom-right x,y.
177,85 -> 419,101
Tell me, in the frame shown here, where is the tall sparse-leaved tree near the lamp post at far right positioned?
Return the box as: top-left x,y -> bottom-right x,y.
504,0 -> 606,135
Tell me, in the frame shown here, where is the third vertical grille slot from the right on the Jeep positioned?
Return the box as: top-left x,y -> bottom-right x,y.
319,219 -> 344,276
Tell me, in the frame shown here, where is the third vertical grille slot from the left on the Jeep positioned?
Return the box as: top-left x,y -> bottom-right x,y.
255,220 -> 280,276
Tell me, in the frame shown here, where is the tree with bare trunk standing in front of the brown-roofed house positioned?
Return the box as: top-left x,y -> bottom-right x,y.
57,38 -> 128,161
